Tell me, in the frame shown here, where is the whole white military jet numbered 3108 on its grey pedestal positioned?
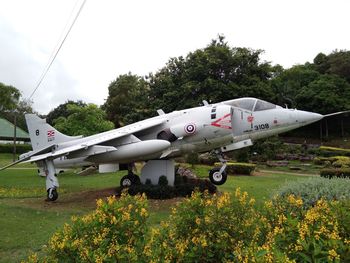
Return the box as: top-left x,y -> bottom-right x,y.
0,98 -> 336,201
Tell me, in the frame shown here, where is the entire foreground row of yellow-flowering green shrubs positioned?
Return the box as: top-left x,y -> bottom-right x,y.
23,188 -> 350,262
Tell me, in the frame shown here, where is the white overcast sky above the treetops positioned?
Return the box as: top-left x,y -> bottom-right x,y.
0,0 -> 350,114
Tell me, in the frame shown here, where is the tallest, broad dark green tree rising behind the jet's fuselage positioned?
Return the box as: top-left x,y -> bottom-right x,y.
148,36 -> 273,112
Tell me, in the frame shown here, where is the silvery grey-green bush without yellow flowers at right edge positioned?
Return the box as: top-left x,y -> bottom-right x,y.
278,177 -> 350,207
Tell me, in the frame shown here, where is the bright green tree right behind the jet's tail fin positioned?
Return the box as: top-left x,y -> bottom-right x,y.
54,104 -> 114,136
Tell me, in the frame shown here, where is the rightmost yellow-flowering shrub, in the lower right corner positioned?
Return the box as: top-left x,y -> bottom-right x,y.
261,195 -> 350,262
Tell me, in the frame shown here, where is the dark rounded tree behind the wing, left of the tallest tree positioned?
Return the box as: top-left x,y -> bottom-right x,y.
103,73 -> 152,127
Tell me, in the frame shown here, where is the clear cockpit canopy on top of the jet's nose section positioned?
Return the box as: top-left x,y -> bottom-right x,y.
222,98 -> 280,111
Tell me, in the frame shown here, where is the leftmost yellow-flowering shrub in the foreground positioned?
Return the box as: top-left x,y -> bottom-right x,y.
42,192 -> 148,262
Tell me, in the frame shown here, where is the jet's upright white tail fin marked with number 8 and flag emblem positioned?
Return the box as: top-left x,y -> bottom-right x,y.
25,114 -> 81,150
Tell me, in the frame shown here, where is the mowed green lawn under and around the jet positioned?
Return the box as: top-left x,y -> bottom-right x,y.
0,155 -> 316,262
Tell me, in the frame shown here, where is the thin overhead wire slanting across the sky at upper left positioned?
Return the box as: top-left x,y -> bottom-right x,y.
28,0 -> 87,100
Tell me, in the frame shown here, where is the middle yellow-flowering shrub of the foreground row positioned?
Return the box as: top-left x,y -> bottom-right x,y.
149,190 -> 261,262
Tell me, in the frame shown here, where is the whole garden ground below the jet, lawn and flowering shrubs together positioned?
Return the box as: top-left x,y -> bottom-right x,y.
0,150 -> 350,262
